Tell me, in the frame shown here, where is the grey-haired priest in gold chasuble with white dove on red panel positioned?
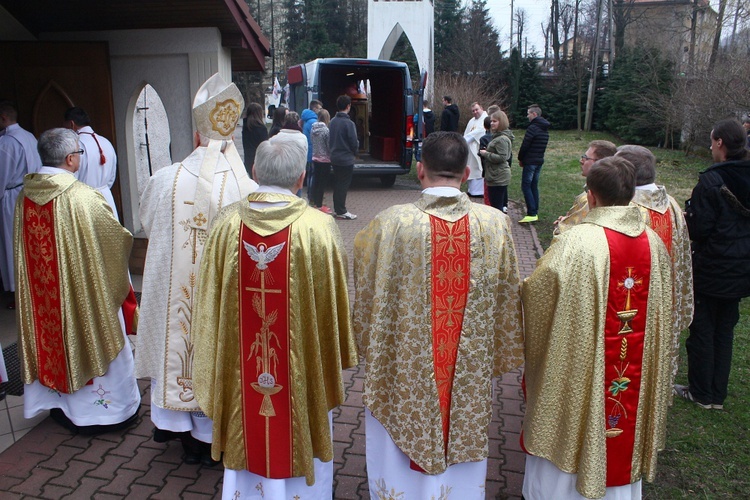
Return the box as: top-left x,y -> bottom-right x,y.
192,138 -> 357,499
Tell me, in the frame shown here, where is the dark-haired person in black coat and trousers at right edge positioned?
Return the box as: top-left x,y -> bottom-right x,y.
675,119 -> 750,410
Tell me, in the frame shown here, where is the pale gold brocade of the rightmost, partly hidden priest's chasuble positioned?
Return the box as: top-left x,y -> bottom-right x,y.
632,186 -> 694,380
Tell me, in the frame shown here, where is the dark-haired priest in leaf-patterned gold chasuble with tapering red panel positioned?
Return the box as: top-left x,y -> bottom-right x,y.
353,132 -> 523,499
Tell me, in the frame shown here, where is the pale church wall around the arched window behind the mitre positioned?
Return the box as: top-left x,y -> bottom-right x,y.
40,28 -> 232,233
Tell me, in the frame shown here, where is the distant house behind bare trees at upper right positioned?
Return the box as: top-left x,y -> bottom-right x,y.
624,0 -> 718,72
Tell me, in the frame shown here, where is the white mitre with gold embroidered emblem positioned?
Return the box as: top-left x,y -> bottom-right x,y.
193,73 -> 245,140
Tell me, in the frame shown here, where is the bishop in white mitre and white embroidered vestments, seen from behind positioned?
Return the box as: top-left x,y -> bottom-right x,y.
136,73 -> 258,464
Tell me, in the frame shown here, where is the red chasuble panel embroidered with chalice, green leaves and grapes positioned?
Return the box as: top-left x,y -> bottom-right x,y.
604,229 -> 651,487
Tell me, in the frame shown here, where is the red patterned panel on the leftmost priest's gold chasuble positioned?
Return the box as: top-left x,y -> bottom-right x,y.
23,198 -> 70,393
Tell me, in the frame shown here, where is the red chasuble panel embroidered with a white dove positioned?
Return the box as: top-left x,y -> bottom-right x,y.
238,225 -> 292,479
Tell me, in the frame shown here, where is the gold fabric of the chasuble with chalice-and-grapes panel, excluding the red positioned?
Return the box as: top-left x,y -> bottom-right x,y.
522,206 -> 672,498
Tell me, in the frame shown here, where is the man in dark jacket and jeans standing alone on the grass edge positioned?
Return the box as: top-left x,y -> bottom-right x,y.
518,104 -> 549,224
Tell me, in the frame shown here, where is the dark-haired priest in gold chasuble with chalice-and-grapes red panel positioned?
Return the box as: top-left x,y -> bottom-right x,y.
521,157 -> 673,500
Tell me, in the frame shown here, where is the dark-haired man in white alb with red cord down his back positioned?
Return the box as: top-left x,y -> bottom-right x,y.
65,107 -> 117,219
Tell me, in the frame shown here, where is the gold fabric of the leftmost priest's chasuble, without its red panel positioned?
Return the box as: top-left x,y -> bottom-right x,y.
14,174 -> 133,393
